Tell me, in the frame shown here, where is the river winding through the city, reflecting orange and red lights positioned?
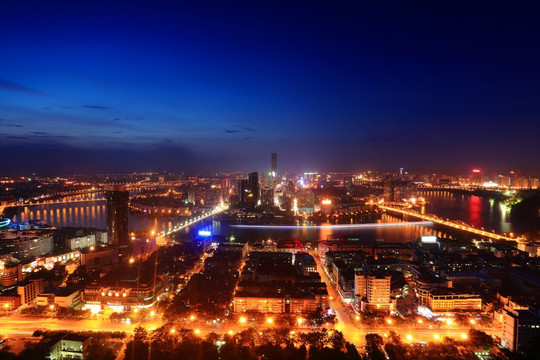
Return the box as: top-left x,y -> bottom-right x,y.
7,191 -> 514,242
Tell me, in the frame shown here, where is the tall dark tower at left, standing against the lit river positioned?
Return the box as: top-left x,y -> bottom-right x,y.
105,185 -> 129,246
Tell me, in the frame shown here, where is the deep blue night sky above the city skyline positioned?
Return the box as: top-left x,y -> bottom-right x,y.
0,0 -> 540,175
